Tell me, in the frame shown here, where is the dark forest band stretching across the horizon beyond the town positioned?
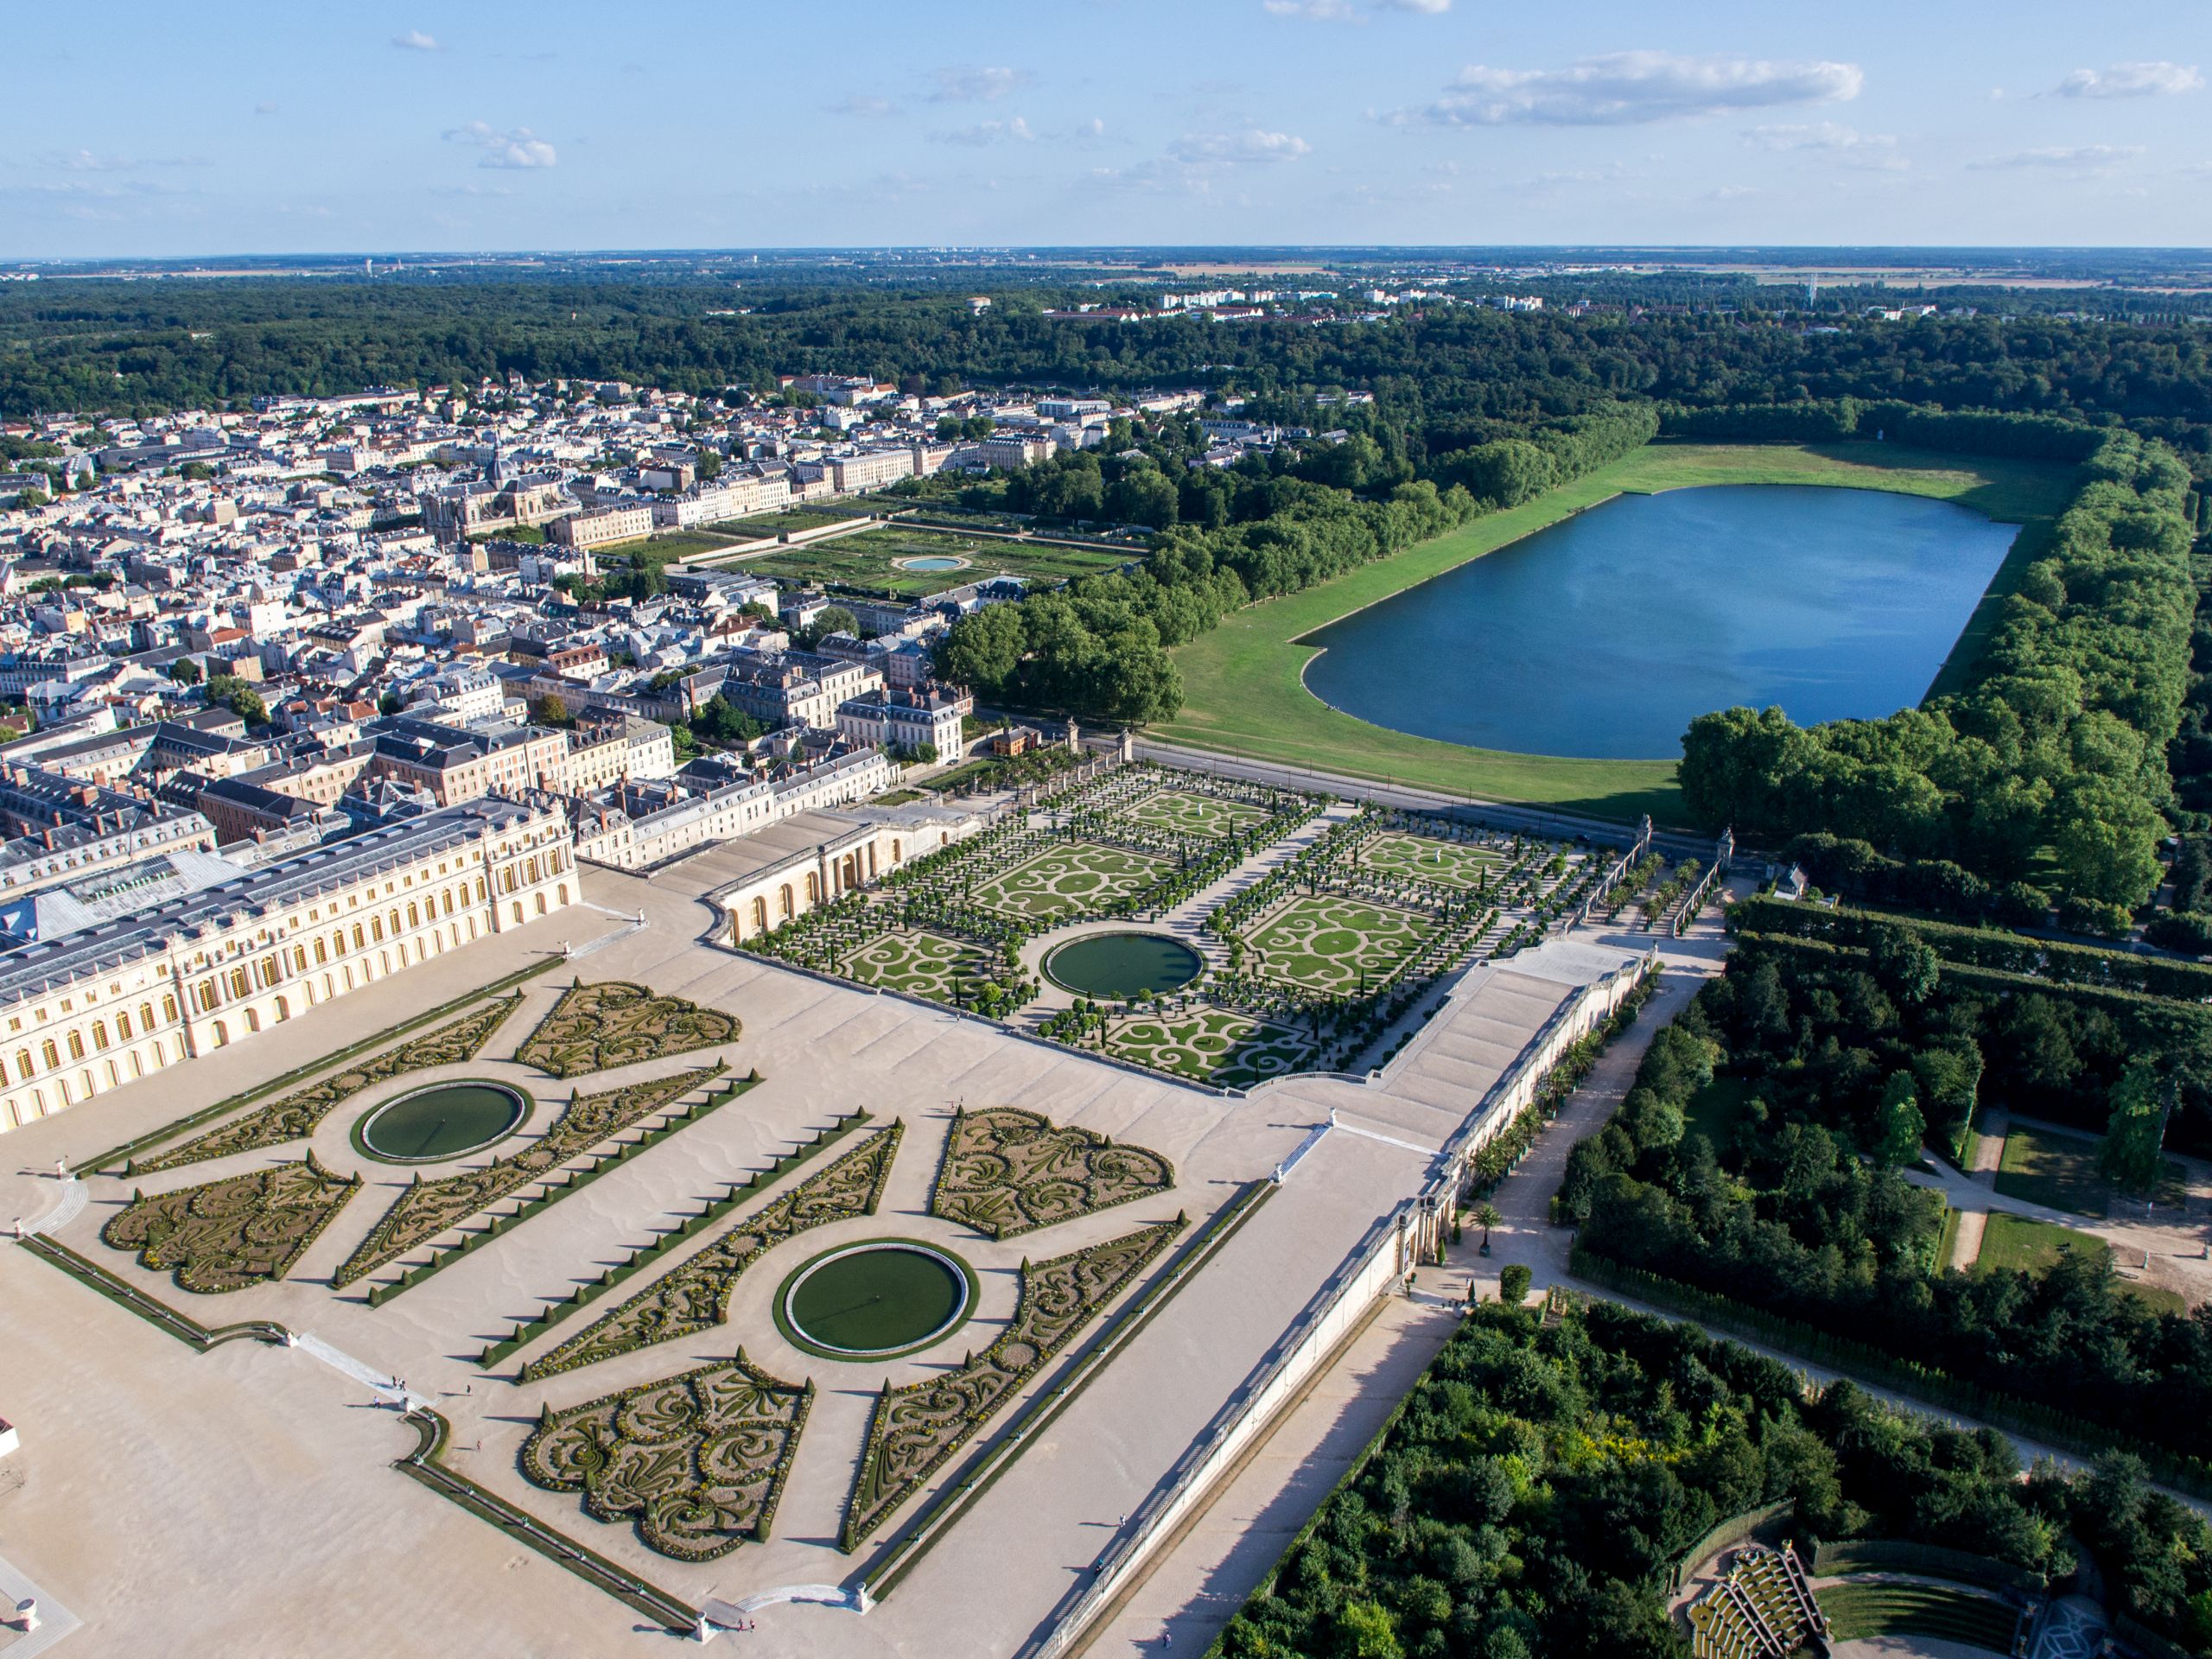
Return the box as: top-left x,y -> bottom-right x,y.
0,272 -> 2212,465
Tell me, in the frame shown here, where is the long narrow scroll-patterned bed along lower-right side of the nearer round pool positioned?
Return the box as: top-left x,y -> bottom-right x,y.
838,1217 -> 1184,1551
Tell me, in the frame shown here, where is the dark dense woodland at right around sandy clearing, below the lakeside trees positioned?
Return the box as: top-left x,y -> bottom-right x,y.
1560,925 -> 2212,1460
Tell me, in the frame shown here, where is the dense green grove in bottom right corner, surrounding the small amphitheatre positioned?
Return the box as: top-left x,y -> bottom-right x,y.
1219,1303 -> 2212,1659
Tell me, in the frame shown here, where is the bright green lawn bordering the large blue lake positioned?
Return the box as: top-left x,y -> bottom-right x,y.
1150,442 -> 2073,823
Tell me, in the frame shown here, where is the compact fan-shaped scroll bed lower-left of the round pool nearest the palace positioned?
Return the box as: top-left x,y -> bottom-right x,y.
99,1153 -> 360,1296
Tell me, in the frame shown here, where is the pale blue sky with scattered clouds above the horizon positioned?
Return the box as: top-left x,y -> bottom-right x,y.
0,0 -> 2212,259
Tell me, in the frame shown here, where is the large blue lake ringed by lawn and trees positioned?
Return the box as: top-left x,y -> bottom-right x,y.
1305,485 -> 2018,759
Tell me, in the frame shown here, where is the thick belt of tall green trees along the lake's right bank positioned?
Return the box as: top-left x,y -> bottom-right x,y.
1681,434 -> 2196,909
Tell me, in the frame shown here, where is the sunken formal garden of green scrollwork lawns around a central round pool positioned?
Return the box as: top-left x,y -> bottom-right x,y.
746,766 -> 1652,1089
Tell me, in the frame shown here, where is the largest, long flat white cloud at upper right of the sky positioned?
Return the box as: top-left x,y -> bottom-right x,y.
1391,51 -> 1865,126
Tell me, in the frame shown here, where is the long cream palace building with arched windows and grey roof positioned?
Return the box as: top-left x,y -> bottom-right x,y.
0,797 -> 582,1130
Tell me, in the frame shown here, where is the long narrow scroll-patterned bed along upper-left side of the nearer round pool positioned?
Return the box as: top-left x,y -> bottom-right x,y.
522,1122 -> 905,1382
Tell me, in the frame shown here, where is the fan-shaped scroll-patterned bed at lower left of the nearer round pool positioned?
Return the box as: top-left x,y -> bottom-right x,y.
522,1350 -> 814,1561
